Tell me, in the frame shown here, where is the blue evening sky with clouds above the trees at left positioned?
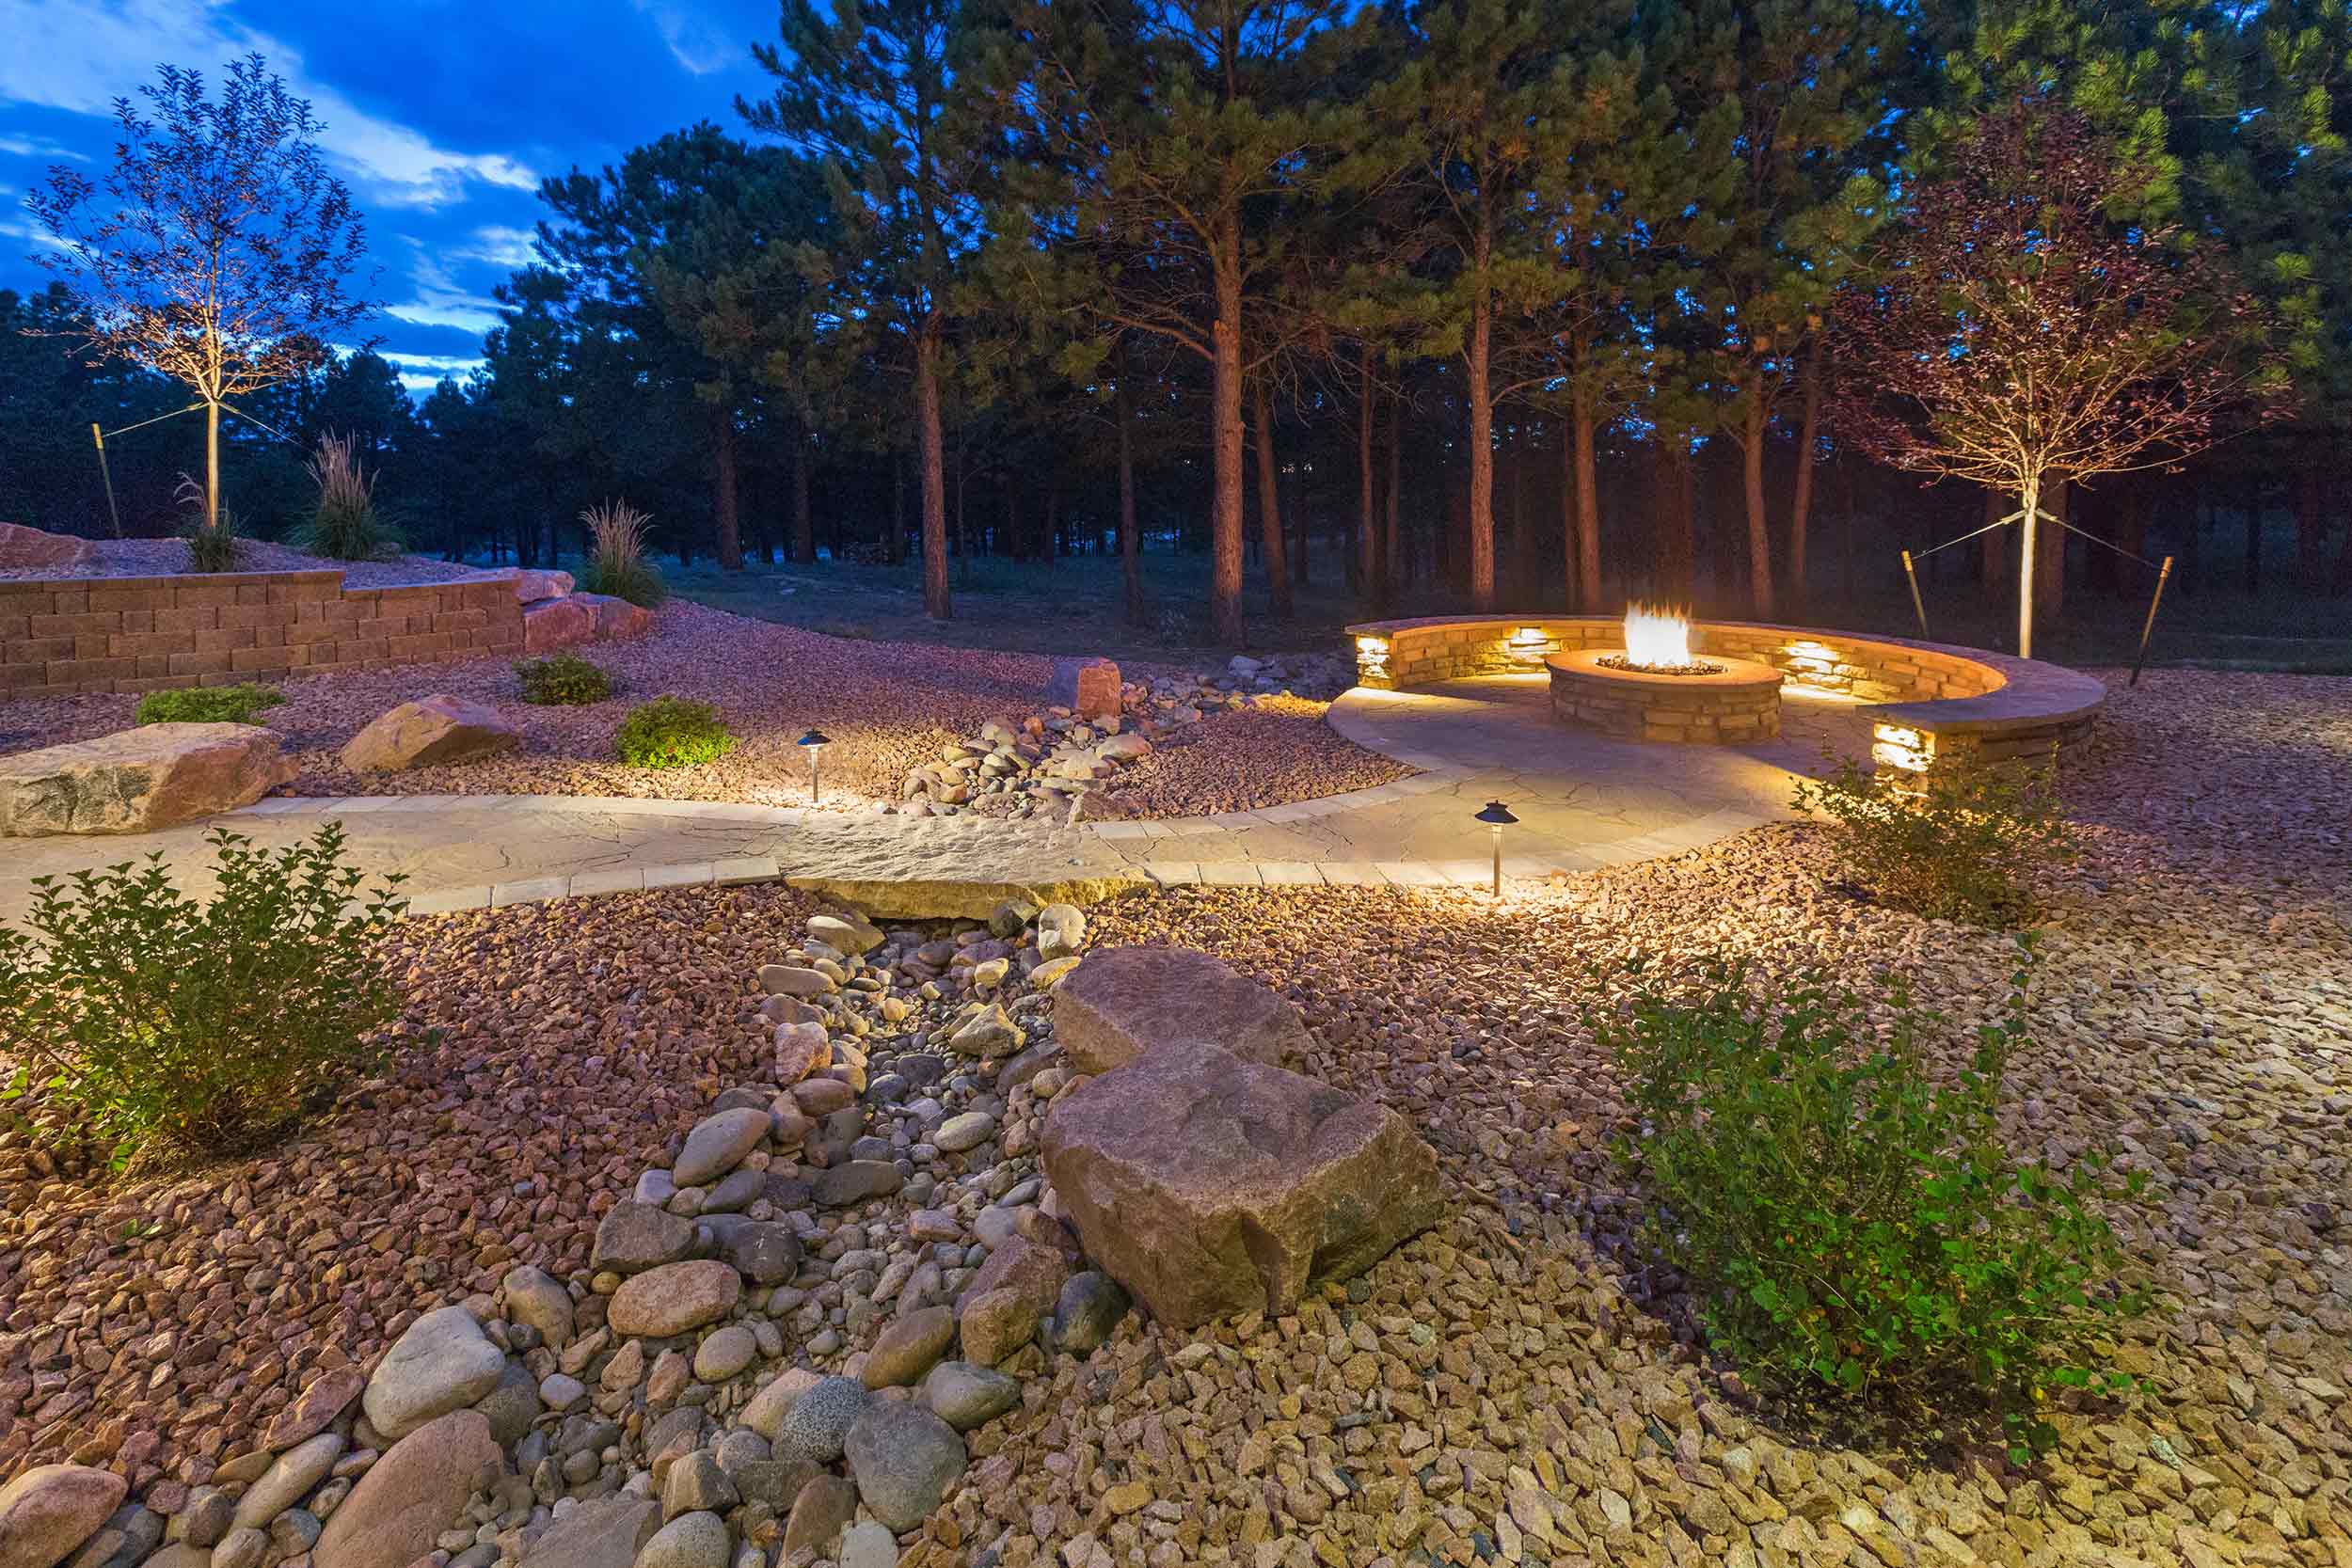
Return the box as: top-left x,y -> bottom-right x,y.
0,0 -> 776,392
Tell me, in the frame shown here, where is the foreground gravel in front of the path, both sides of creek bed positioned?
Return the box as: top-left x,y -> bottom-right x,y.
0,674 -> 2352,1568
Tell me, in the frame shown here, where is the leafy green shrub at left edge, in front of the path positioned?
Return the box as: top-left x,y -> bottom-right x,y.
0,823 -> 405,1164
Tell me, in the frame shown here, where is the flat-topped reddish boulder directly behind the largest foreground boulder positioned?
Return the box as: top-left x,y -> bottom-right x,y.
1054,947 -> 1315,1072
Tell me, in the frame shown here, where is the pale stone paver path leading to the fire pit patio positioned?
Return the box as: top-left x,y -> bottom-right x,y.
0,674 -> 1867,919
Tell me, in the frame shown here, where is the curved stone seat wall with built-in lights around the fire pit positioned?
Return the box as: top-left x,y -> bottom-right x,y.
1348,616 -> 2107,768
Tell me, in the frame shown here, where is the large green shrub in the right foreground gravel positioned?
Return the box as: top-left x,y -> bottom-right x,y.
1593,945 -> 2148,1455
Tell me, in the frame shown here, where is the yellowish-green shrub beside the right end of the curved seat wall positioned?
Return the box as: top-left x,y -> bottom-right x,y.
1795,754 -> 2074,927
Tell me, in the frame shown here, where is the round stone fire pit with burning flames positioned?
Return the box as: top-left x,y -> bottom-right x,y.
1543,604 -> 1781,743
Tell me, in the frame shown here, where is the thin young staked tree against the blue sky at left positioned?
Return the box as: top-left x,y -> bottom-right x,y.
26,54 -> 374,527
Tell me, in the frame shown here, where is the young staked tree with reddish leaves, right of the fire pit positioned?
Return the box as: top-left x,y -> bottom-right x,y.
1830,101 -> 2291,656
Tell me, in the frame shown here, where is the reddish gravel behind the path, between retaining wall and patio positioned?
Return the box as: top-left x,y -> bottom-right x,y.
0,602 -> 1411,816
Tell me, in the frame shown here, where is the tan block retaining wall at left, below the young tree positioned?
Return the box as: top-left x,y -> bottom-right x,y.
0,571 -> 522,698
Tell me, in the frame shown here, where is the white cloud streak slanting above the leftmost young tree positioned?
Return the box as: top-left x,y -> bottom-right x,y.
0,0 -> 539,207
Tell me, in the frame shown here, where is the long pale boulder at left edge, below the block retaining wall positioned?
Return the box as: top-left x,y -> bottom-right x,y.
0,724 -> 294,837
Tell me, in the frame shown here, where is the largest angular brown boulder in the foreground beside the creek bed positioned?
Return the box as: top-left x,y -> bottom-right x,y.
1042,1034 -> 1444,1331
